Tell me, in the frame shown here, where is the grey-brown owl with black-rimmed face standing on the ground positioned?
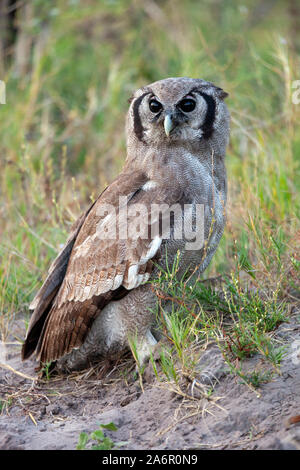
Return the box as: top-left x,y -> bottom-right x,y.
22,77 -> 230,371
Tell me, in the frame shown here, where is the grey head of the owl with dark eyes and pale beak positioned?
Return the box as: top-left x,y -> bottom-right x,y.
127,77 -> 229,150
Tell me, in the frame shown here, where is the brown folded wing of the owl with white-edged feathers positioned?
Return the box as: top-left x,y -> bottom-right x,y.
23,172 -> 182,362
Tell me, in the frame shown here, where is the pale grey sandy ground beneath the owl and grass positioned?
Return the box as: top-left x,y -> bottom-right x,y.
0,309 -> 300,450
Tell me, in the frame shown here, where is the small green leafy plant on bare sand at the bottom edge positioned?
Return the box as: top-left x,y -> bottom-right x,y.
76,423 -> 127,450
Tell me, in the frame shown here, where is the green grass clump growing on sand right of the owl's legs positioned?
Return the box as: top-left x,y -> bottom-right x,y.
152,255 -> 288,392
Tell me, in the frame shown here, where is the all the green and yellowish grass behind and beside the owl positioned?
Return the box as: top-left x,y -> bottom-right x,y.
0,0 -> 300,392
